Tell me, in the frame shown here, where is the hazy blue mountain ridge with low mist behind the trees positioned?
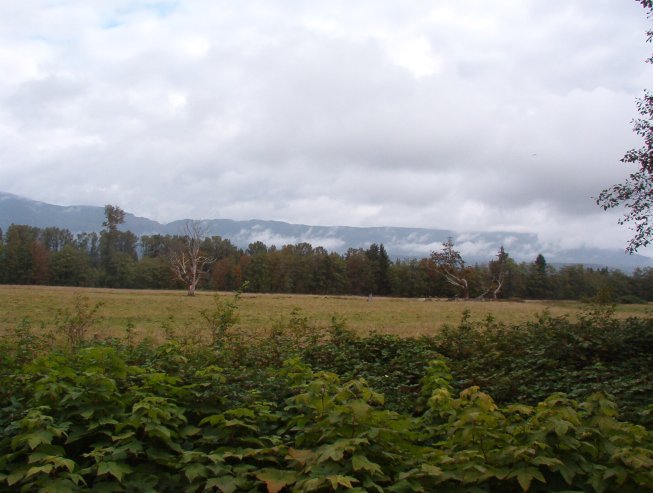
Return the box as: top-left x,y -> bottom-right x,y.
0,192 -> 653,271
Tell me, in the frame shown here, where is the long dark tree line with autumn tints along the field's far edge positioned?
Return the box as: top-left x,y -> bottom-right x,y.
0,206 -> 653,302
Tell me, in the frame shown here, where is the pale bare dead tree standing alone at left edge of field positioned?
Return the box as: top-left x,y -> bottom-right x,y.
169,221 -> 215,296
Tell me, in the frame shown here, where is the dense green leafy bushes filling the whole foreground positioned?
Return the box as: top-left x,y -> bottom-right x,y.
0,299 -> 653,492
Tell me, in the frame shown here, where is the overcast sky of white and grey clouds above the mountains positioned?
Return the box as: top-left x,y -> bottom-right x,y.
0,0 -> 653,254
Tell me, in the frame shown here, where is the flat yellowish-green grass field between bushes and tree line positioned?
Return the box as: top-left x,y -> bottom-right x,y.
0,286 -> 649,341
